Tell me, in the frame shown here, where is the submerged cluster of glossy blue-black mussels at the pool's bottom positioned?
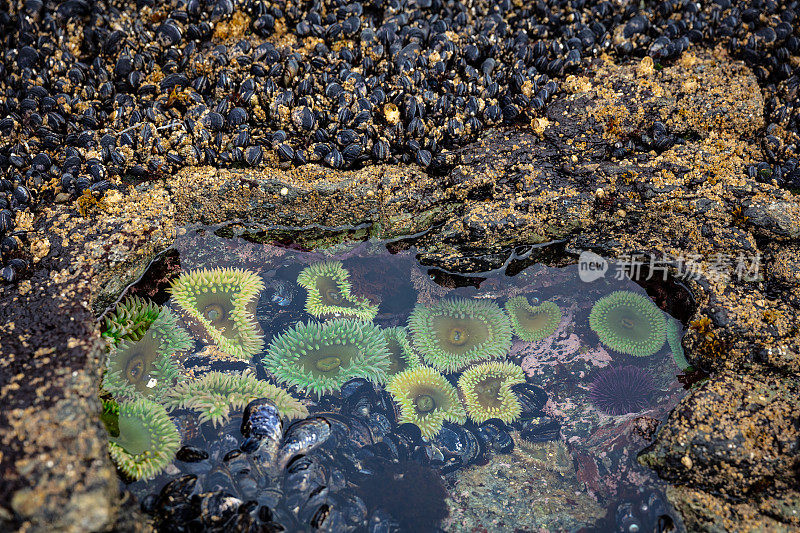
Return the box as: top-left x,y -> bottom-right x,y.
142,379 -> 559,532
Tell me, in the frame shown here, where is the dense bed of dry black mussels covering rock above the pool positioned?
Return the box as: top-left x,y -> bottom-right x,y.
0,0 -> 800,281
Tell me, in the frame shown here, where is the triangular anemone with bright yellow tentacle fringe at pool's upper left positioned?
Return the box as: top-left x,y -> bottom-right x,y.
170,268 -> 264,361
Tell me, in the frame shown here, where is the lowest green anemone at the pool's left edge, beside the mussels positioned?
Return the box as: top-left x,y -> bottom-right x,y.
108,398 -> 181,479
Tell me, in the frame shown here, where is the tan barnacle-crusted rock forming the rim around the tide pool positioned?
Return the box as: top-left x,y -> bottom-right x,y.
0,51 -> 800,531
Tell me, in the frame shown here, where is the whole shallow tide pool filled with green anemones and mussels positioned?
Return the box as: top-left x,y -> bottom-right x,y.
97,228 -> 688,532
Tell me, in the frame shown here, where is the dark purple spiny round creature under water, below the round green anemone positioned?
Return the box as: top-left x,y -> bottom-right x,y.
589,365 -> 656,416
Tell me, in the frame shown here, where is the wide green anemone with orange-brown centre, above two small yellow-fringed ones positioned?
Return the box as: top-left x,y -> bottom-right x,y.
408,298 -> 511,372
